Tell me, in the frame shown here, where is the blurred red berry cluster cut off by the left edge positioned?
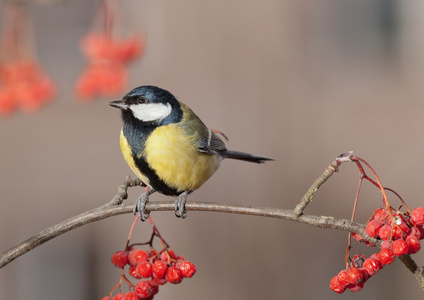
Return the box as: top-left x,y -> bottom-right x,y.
0,3 -> 56,115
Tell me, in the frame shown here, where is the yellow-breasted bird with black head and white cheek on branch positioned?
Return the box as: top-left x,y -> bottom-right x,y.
109,85 -> 274,221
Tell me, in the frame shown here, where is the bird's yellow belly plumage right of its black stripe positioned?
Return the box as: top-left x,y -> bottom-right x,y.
144,124 -> 219,191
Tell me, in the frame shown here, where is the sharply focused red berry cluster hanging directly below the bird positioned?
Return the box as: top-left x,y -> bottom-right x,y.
102,218 -> 196,300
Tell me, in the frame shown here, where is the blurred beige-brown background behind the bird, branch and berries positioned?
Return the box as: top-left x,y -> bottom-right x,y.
0,0 -> 424,300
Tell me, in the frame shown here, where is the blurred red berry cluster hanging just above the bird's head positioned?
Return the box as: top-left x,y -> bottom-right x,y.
75,1 -> 145,101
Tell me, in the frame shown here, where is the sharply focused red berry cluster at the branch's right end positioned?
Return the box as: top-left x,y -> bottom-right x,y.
330,207 -> 424,294
